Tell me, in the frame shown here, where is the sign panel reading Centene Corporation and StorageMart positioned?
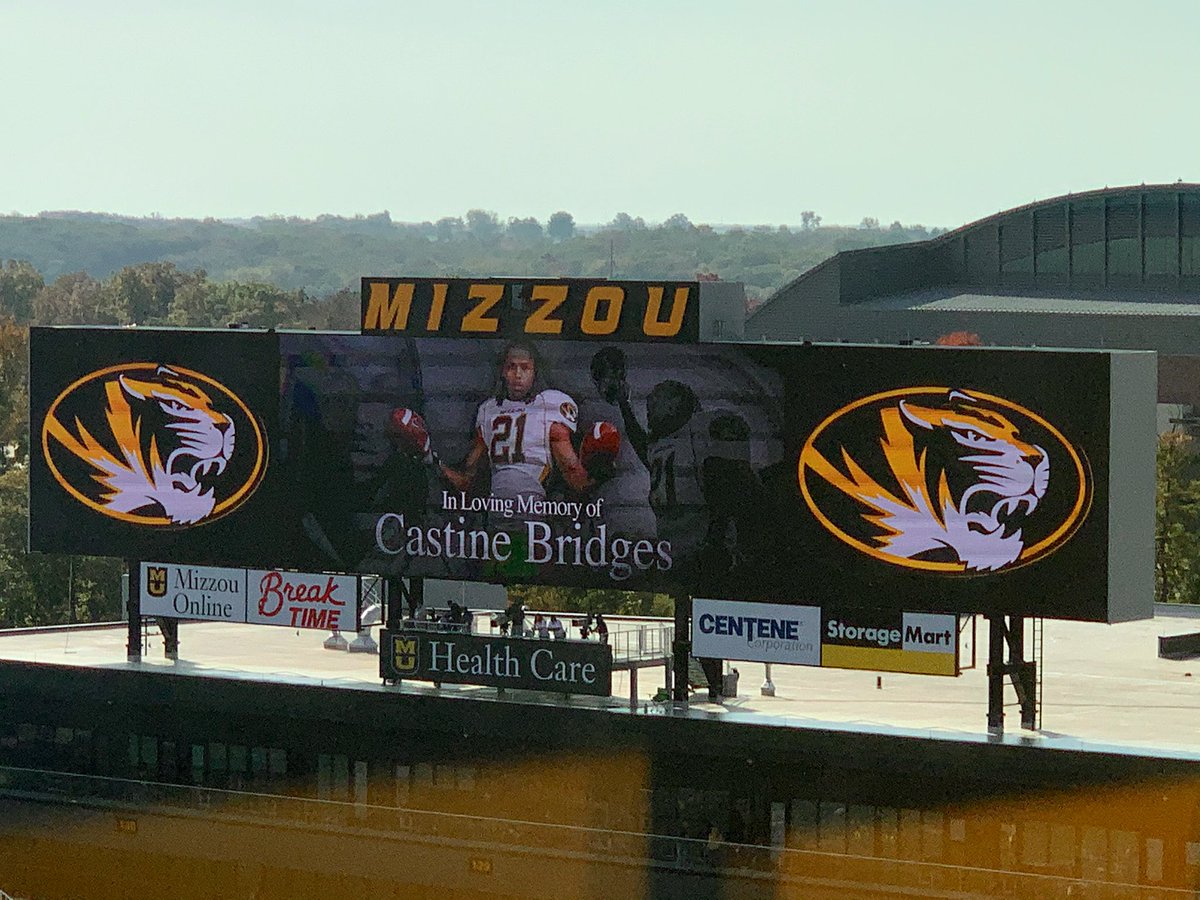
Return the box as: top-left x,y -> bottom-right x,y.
691,600 -> 959,676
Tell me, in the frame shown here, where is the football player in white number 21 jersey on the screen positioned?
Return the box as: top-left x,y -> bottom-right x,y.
392,341 -> 616,520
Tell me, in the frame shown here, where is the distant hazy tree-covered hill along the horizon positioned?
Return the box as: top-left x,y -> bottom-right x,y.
0,210 -> 938,302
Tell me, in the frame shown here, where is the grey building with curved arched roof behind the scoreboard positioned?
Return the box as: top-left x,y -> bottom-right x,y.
746,182 -> 1200,353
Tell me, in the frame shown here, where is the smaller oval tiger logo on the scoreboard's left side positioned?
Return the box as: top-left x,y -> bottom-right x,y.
42,362 -> 266,527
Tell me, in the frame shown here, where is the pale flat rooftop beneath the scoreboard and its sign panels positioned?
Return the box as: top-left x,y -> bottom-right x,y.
0,611 -> 1200,760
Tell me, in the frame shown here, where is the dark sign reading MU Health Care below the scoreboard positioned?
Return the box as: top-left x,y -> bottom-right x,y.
379,631 -> 612,697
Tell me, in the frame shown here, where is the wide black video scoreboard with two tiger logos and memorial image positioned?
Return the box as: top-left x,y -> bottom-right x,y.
30,328 -> 1156,622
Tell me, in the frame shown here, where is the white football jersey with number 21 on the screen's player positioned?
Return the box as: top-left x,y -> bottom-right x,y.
475,390 -> 578,497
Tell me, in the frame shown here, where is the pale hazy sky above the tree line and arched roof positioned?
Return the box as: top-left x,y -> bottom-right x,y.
0,0 -> 1200,229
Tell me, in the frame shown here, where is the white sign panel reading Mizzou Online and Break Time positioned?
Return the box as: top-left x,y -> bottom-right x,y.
140,563 -> 359,631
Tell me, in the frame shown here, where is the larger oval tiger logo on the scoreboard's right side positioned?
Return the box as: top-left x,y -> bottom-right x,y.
799,388 -> 1092,575
